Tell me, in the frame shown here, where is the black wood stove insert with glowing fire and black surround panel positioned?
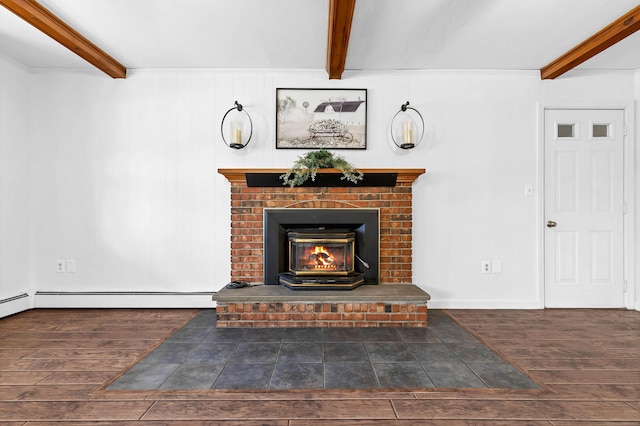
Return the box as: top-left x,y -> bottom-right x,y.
264,209 -> 380,290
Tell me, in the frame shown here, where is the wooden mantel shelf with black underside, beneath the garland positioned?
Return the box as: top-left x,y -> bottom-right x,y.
218,169 -> 425,187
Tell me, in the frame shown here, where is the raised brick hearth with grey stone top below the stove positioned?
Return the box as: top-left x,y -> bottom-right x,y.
214,284 -> 429,327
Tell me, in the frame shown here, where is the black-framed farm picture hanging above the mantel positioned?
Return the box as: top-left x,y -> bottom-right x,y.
276,89 -> 367,149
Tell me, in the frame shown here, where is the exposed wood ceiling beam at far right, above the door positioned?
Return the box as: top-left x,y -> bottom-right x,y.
540,6 -> 640,80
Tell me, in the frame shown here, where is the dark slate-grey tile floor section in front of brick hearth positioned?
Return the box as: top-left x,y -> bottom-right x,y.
107,309 -> 539,390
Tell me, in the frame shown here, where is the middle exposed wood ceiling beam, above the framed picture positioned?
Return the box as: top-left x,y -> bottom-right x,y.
327,0 -> 356,80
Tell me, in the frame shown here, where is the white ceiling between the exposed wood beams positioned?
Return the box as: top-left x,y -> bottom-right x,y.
0,0 -> 640,75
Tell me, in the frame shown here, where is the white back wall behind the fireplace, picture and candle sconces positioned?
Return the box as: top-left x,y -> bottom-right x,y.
15,70 -> 640,308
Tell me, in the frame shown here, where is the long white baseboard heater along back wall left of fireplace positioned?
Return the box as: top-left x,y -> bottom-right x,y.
34,291 -> 216,309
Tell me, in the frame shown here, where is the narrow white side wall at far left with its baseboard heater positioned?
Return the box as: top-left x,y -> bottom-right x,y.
0,55 -> 31,317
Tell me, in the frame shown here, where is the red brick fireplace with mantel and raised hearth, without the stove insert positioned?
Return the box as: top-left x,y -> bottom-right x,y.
214,169 -> 429,327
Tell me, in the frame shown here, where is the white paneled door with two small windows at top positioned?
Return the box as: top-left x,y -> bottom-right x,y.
544,109 -> 624,308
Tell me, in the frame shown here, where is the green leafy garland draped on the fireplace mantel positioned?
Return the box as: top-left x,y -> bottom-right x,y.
280,149 -> 364,188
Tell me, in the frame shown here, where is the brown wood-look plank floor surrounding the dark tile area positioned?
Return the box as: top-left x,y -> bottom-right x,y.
0,309 -> 640,426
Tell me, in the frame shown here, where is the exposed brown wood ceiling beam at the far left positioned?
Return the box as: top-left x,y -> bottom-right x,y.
0,0 -> 127,78
